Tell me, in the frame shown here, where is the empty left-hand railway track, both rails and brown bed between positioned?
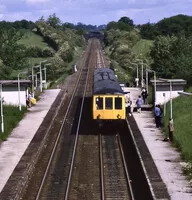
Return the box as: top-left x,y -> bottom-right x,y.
35,39 -> 97,200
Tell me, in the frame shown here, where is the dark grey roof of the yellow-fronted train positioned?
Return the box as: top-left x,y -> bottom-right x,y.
93,68 -> 123,94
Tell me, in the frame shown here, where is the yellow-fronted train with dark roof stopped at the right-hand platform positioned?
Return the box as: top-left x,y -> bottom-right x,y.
92,68 -> 126,121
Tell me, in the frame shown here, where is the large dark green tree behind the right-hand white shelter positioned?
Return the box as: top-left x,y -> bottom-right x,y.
151,36 -> 192,84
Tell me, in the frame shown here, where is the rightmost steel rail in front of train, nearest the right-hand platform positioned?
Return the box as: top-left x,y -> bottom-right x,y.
116,133 -> 135,200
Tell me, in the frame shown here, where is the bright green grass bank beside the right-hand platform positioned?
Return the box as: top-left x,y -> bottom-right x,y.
163,96 -> 192,182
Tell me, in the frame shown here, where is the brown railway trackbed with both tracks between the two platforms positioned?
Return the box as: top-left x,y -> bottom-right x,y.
0,39 -> 158,200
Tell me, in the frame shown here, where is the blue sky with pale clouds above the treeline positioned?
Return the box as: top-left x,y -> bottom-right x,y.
0,0 -> 192,25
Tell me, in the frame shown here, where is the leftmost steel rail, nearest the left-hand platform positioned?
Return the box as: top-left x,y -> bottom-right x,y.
35,41 -> 94,200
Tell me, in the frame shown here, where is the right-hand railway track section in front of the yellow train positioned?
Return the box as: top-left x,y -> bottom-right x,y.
100,133 -> 134,200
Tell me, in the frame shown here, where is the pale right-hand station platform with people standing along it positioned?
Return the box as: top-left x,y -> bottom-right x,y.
129,88 -> 192,200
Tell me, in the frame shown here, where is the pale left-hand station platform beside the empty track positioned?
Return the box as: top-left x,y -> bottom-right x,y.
0,89 -> 60,192
